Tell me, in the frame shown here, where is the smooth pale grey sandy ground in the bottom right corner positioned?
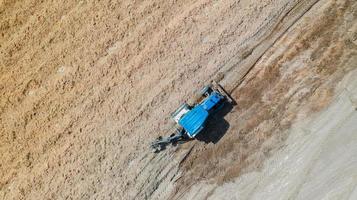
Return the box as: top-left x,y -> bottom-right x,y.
203,67 -> 357,199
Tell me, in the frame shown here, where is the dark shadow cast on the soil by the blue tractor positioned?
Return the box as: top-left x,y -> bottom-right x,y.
195,103 -> 235,144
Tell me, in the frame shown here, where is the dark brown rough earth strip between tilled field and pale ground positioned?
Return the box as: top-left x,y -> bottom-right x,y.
177,2 -> 357,190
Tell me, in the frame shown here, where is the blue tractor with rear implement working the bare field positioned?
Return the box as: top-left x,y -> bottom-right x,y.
151,82 -> 233,153
